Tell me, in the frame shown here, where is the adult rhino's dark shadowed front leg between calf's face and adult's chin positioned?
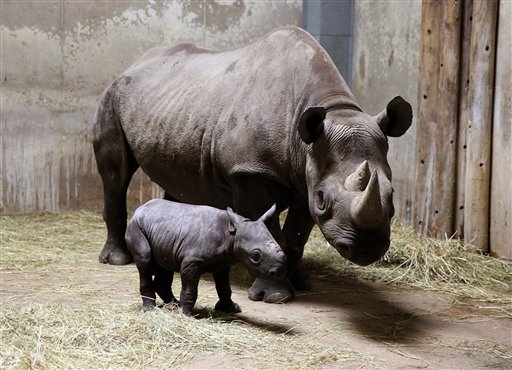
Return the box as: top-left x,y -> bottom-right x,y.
283,203 -> 315,290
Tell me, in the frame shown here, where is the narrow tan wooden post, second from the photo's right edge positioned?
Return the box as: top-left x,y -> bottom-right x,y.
464,0 -> 498,252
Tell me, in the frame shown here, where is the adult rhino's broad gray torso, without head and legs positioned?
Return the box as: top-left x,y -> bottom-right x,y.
107,27 -> 348,207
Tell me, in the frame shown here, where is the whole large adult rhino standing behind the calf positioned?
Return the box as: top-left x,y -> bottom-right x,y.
94,27 -> 412,302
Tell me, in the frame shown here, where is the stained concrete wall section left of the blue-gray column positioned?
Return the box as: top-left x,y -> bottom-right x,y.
0,0 -> 302,212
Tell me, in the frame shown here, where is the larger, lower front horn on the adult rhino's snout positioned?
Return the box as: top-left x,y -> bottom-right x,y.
351,170 -> 383,228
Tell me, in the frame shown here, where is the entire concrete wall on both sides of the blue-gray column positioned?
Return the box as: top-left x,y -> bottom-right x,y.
0,0 -> 421,215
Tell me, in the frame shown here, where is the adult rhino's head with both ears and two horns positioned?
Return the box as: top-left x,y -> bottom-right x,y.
298,97 -> 412,266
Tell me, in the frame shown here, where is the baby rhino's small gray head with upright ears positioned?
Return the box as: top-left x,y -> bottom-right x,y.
227,204 -> 286,280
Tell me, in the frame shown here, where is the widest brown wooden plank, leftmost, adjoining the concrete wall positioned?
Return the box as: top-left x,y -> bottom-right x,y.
413,0 -> 462,237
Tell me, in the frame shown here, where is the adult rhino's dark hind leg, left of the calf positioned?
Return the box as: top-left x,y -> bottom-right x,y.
93,92 -> 139,265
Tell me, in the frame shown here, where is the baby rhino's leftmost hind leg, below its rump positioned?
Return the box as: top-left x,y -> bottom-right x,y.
125,222 -> 156,311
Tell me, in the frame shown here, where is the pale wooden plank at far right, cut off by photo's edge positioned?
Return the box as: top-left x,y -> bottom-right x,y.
490,0 -> 512,260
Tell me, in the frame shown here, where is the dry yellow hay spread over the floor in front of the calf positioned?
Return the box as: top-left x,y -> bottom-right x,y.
0,304 -> 360,368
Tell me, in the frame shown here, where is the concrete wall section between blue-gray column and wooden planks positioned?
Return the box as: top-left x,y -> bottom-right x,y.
352,0 -> 421,221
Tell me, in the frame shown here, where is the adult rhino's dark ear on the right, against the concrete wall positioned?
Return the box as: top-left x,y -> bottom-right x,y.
375,96 -> 412,137
